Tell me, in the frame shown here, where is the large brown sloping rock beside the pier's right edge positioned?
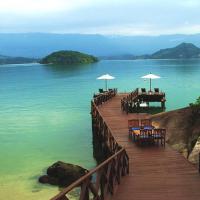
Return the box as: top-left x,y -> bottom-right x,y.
152,107 -> 200,164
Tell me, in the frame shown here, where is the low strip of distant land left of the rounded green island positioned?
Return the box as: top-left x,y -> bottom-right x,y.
0,55 -> 38,65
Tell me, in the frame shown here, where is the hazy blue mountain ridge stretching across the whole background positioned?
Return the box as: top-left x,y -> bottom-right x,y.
0,33 -> 200,58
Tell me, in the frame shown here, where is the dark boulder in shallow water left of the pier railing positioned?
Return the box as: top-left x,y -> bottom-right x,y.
39,161 -> 88,187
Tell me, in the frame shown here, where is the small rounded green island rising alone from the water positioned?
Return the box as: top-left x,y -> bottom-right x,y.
40,51 -> 98,65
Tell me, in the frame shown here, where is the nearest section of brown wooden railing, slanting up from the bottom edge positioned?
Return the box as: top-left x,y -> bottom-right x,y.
51,149 -> 128,200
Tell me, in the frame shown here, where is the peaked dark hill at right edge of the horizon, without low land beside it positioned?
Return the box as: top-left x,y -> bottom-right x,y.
151,43 -> 200,59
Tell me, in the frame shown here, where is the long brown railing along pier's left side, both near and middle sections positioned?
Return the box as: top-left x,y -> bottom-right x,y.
51,91 -> 129,200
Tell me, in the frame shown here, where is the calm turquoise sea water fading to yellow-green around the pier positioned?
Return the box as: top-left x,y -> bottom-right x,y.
0,60 -> 200,200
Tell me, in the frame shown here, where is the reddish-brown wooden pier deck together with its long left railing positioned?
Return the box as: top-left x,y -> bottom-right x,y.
52,93 -> 200,200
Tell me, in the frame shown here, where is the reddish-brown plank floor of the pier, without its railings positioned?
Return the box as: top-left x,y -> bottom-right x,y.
99,94 -> 200,200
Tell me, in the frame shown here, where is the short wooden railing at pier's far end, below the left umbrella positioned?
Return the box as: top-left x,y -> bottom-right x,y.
93,88 -> 117,106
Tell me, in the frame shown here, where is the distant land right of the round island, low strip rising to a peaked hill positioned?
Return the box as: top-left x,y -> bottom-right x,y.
101,43 -> 200,60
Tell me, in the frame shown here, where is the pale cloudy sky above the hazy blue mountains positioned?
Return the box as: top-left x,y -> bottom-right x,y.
0,0 -> 200,35
